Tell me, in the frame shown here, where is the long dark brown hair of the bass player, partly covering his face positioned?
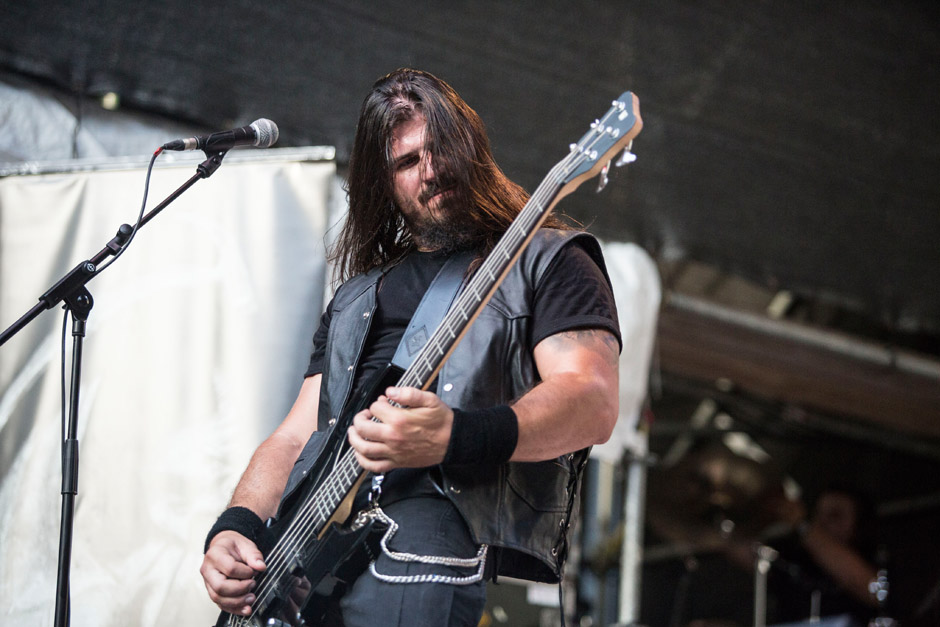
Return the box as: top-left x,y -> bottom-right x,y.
329,69 -> 565,280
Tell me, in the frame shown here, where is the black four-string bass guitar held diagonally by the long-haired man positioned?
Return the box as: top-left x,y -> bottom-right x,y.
216,92 -> 643,627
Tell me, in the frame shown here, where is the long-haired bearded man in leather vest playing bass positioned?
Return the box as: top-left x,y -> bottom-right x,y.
201,69 -> 620,627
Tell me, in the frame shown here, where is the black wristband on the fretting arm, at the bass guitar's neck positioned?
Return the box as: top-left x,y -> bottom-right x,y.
442,405 -> 519,464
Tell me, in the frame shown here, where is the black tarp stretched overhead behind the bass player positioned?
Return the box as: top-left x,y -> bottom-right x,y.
0,0 -> 940,344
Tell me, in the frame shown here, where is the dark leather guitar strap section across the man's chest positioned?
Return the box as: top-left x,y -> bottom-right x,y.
392,252 -> 475,370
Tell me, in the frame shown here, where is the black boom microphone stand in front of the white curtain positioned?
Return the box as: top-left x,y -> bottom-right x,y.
0,150 -> 228,627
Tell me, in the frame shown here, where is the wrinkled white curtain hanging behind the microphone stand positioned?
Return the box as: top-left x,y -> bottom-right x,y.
0,149 -> 336,627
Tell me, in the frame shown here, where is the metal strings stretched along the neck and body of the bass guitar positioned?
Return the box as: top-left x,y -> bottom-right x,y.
236,105 -> 622,625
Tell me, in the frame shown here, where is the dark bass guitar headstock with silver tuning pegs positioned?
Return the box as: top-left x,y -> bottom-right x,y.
562,91 -> 643,193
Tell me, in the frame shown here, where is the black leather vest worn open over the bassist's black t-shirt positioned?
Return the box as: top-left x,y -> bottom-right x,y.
298,229 -> 609,582
